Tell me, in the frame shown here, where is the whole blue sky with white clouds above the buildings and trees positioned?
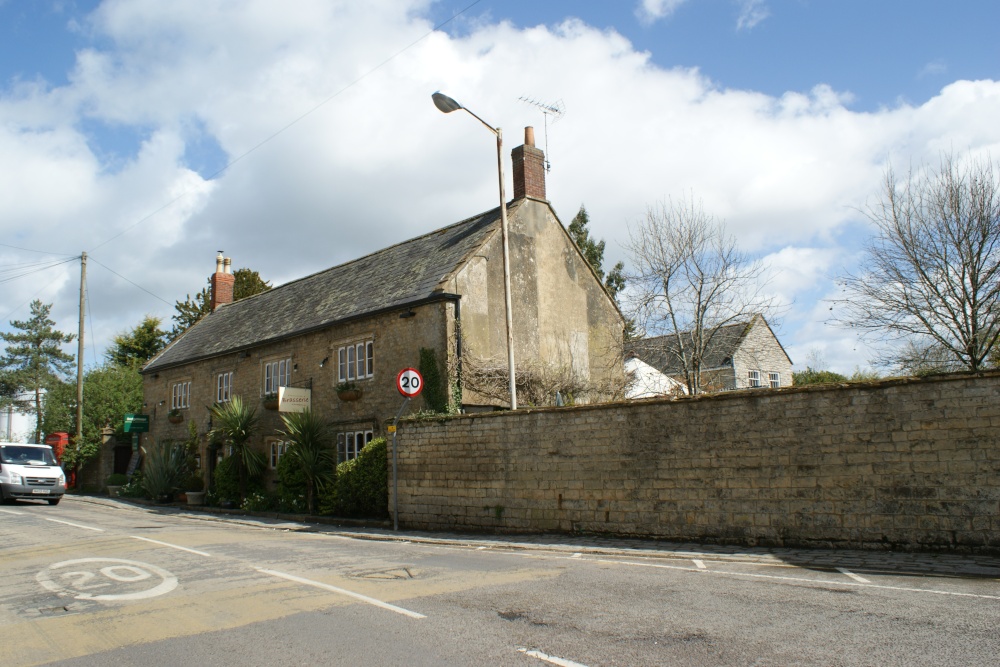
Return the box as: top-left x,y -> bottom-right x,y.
0,0 -> 1000,386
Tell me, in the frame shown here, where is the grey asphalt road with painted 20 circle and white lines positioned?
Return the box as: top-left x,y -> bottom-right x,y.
0,496 -> 1000,667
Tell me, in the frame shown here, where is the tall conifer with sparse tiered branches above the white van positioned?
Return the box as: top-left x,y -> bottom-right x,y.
0,299 -> 76,442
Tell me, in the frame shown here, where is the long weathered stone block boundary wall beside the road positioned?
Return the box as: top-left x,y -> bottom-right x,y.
389,372 -> 1000,552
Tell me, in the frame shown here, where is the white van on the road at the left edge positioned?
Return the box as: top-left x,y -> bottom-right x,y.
0,442 -> 66,505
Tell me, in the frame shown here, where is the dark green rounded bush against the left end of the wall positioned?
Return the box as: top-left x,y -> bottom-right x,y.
320,438 -> 389,519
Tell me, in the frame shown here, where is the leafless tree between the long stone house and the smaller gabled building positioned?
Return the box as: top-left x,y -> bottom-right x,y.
626,199 -> 775,395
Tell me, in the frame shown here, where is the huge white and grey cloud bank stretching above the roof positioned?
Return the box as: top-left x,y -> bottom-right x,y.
0,0 -> 1000,370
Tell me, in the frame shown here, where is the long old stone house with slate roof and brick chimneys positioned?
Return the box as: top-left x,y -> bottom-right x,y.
142,128 -> 624,482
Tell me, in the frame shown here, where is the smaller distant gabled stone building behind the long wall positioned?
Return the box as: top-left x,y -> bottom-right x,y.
626,315 -> 792,398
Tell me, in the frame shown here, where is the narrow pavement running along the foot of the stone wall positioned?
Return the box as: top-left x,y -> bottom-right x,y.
66,494 -> 1000,579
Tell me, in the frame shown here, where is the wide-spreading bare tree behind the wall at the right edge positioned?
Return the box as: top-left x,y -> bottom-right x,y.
835,155 -> 1000,371
